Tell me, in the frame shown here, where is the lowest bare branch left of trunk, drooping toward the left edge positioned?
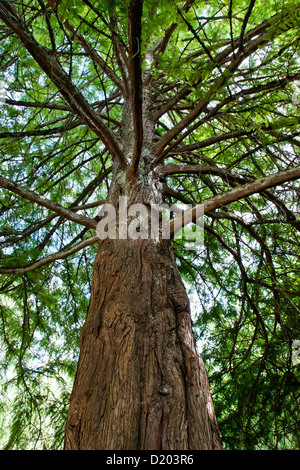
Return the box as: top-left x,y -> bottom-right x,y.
0,235 -> 99,274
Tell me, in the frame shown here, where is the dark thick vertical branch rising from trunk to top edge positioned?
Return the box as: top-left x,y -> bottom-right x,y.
128,0 -> 143,174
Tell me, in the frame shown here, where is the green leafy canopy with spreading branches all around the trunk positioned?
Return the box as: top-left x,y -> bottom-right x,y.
0,0 -> 300,449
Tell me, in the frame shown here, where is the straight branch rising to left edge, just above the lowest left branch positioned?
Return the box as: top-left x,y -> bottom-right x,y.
0,176 -> 97,229
